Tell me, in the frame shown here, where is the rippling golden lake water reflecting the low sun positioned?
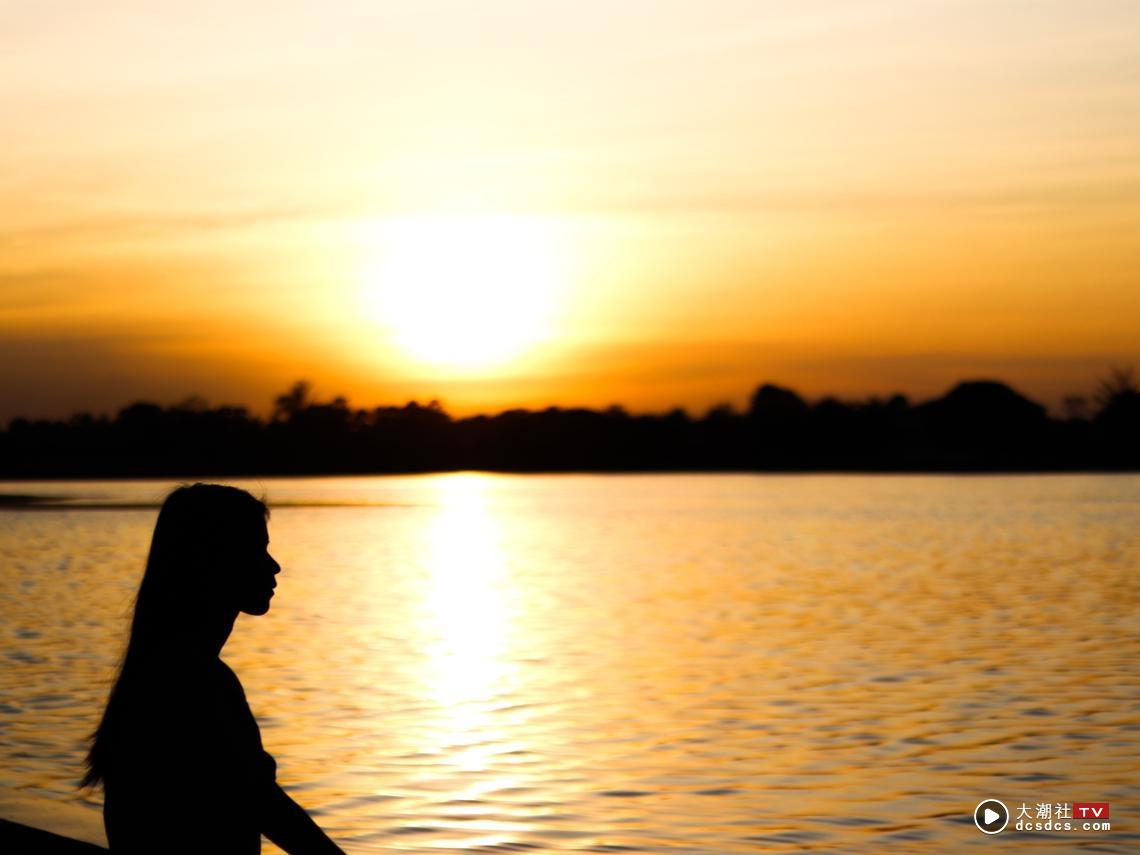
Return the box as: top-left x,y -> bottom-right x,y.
0,474 -> 1140,853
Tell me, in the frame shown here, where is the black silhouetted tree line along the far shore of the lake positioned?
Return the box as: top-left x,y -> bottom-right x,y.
0,369 -> 1140,479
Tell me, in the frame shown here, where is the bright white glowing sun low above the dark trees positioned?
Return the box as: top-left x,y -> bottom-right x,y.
361,214 -> 564,372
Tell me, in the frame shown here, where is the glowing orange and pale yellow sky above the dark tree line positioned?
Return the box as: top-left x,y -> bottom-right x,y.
0,0 -> 1140,421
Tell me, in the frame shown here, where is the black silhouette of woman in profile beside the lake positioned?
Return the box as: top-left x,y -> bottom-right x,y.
83,483 -> 341,855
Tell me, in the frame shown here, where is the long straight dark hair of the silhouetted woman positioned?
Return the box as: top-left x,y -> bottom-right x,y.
80,483 -> 269,787
